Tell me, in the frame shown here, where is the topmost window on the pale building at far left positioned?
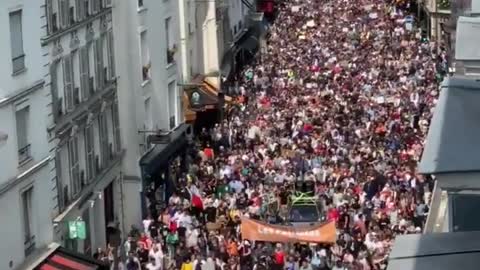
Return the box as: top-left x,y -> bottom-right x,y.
10,10 -> 25,74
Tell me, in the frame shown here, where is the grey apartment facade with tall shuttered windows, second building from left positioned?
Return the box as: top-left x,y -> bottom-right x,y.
42,0 -> 123,253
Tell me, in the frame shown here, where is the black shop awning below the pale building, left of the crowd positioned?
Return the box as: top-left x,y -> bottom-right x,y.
140,124 -> 190,175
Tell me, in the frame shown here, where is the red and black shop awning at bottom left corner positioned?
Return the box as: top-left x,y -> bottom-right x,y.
31,247 -> 109,270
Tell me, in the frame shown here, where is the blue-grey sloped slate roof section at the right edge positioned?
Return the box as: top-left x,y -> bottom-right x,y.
419,76 -> 480,174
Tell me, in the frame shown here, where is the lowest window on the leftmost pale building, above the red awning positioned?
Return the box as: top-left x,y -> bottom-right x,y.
22,187 -> 35,256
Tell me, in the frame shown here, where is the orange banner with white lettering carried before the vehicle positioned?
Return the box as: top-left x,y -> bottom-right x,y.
241,218 -> 337,244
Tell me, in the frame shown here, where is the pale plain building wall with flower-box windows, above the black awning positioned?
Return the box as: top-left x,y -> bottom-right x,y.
113,0 -> 183,232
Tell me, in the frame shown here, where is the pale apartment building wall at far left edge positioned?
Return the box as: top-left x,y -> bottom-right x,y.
0,0 -> 53,269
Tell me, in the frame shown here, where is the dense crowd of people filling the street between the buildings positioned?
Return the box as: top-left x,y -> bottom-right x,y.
116,0 -> 446,270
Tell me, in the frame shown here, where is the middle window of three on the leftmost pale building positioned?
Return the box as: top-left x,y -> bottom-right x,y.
15,106 -> 31,164
